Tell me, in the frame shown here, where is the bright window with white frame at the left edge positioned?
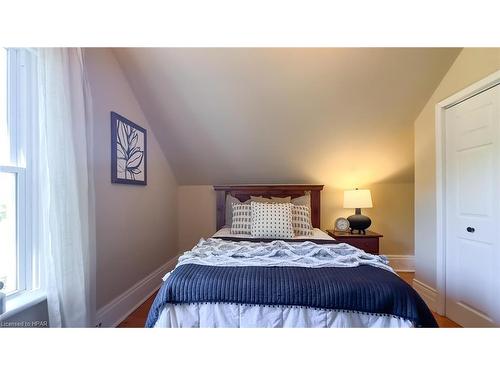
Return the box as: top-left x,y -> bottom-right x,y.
0,48 -> 39,298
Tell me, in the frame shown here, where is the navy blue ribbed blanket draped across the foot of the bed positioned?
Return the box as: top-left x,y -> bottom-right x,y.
146,264 -> 437,327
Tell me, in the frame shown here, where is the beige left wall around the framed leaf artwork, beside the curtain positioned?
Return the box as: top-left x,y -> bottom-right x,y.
85,49 -> 177,308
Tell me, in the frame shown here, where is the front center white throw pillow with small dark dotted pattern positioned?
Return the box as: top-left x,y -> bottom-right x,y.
250,202 -> 293,238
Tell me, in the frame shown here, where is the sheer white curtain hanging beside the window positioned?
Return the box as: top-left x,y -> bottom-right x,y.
32,48 -> 95,327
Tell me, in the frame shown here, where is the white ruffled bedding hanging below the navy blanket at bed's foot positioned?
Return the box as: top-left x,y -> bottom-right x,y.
155,303 -> 413,328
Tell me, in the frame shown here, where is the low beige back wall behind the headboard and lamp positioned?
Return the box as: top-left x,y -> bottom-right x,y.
178,183 -> 413,255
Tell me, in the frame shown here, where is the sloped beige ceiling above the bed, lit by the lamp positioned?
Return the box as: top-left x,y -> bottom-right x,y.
114,48 -> 460,188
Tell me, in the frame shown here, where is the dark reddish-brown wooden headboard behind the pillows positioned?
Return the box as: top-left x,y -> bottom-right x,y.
214,185 -> 323,230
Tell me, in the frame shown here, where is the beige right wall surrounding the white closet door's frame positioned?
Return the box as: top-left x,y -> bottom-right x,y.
414,48 -> 500,287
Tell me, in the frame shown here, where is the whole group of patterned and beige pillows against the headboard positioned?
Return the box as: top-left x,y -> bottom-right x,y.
230,196 -> 313,239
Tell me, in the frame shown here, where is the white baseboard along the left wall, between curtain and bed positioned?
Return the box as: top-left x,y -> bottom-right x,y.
97,255 -> 180,327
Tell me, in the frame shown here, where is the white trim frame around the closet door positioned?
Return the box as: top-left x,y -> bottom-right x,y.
435,70 -> 500,315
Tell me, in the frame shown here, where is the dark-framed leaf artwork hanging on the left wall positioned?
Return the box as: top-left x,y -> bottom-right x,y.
111,112 -> 147,185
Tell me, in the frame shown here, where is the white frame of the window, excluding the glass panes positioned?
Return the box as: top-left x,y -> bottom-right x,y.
0,48 -> 40,302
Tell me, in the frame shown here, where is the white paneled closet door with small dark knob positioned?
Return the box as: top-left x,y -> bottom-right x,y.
445,86 -> 500,327
